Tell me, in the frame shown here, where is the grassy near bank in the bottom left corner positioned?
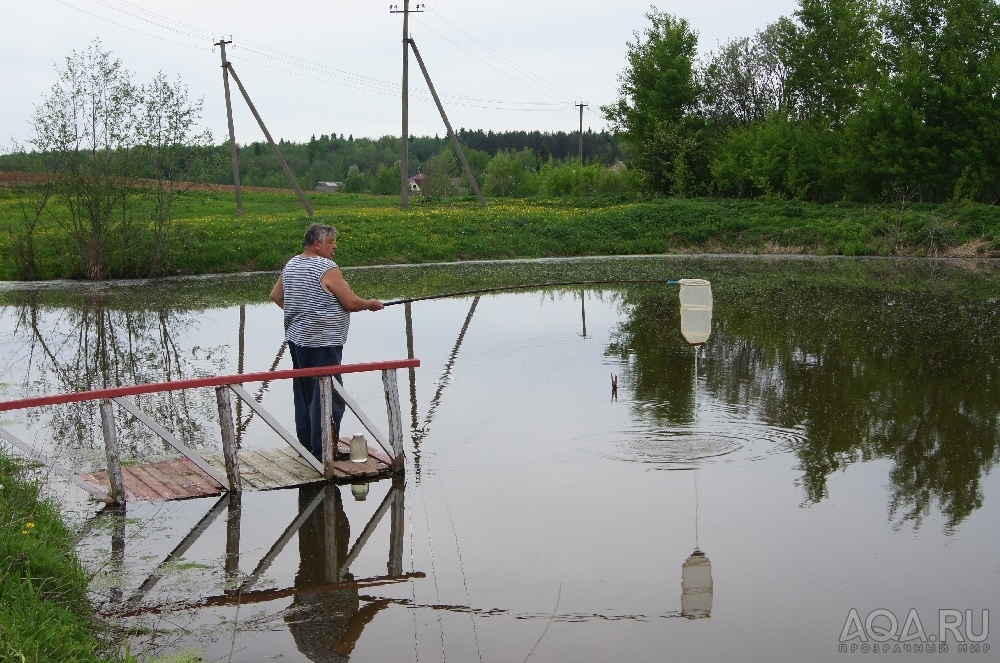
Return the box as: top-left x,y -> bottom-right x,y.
0,449 -> 125,663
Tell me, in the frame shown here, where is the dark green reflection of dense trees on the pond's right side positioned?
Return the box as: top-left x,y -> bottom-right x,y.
609,279 -> 1000,528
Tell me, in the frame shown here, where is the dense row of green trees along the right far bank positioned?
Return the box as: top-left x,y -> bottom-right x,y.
602,0 -> 1000,204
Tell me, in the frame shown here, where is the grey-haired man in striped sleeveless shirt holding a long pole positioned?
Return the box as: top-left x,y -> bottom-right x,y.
271,223 -> 383,460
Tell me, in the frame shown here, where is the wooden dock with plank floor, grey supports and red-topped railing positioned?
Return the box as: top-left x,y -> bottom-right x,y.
0,358 -> 420,505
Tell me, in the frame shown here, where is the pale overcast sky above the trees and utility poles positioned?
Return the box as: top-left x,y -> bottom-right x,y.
0,0 -> 797,151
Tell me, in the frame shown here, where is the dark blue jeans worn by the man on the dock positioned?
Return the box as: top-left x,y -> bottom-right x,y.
288,341 -> 347,460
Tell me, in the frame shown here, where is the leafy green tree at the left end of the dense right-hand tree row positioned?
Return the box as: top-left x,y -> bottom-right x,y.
601,8 -> 701,192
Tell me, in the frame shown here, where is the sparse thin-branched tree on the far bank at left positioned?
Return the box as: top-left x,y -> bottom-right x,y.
31,40 -> 211,279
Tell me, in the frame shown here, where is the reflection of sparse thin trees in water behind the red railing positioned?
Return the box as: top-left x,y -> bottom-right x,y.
11,289 -> 225,464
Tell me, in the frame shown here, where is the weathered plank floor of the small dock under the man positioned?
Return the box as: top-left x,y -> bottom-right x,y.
80,438 -> 392,502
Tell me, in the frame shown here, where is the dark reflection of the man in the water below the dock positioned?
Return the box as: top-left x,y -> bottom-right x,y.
285,484 -> 388,663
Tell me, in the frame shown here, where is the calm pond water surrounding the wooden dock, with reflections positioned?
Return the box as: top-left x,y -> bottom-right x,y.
0,257 -> 1000,662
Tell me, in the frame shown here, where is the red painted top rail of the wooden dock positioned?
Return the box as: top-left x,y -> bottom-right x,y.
0,359 -> 420,412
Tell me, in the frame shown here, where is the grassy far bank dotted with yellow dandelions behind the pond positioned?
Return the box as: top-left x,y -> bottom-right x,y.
0,190 -> 1000,280
